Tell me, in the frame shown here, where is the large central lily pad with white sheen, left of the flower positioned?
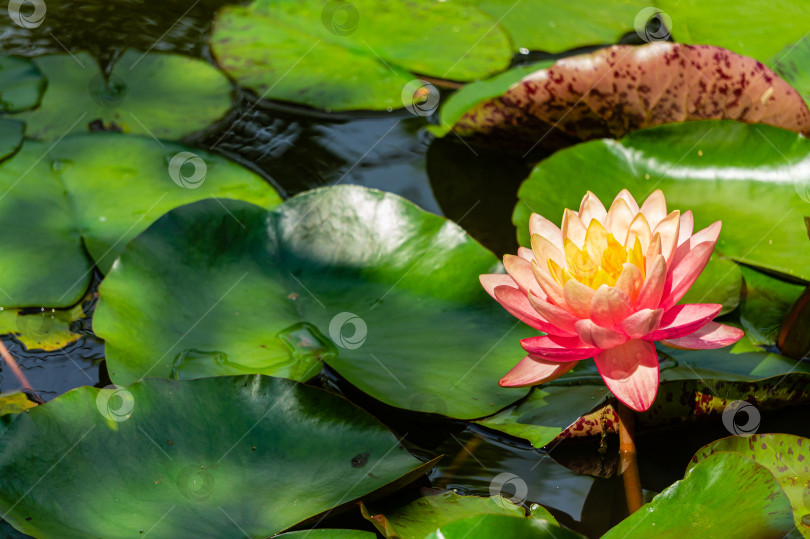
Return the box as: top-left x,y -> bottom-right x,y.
93,186 -> 533,419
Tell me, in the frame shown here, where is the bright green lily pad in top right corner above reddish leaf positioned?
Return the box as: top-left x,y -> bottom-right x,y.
654,0 -> 810,62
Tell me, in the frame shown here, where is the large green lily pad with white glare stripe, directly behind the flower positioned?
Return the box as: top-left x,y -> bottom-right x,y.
512,121 -> 810,280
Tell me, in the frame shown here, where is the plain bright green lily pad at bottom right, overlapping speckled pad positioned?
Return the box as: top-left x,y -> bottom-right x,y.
603,453 -> 793,539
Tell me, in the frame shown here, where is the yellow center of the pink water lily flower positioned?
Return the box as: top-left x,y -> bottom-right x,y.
548,219 -> 645,290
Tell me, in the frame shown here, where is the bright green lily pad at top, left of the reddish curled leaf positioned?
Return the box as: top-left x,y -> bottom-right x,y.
211,0 -> 512,110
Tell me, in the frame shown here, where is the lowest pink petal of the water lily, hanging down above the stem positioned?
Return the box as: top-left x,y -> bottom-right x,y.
594,339 -> 658,412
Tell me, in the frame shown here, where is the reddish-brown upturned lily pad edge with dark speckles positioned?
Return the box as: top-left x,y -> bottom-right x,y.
443,42 -> 810,151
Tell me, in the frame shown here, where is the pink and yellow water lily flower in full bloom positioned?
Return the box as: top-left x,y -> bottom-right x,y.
481,190 -> 743,411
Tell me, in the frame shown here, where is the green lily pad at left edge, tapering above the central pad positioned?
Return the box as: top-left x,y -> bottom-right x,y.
0,134 -> 281,308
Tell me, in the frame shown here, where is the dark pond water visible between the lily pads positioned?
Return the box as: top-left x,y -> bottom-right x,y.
0,0 -> 810,537
